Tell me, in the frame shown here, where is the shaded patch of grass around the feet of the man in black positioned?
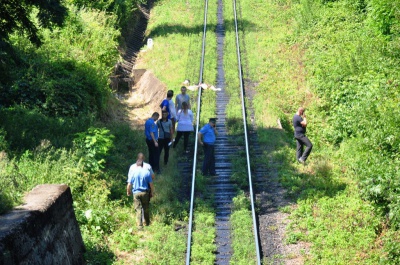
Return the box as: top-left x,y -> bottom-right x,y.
257,125 -> 346,200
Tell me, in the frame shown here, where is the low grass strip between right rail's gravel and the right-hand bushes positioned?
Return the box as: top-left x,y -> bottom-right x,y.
241,1 -> 390,264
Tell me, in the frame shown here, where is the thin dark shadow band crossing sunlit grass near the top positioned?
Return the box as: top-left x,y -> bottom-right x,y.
149,20 -> 255,37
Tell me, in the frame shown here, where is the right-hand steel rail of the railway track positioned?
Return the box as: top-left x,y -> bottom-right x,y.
233,0 -> 261,265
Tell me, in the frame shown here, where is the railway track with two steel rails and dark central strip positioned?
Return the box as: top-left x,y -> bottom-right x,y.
182,0 -> 261,264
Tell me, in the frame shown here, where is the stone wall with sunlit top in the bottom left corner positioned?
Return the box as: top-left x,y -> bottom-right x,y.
0,185 -> 84,265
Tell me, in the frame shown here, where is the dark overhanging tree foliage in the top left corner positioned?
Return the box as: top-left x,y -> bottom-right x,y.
0,0 -> 67,45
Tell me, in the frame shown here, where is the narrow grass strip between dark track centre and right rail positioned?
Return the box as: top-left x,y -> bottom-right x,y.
223,1 -> 256,264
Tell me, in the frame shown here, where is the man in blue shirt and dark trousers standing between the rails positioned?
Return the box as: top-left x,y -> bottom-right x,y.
198,118 -> 218,176
